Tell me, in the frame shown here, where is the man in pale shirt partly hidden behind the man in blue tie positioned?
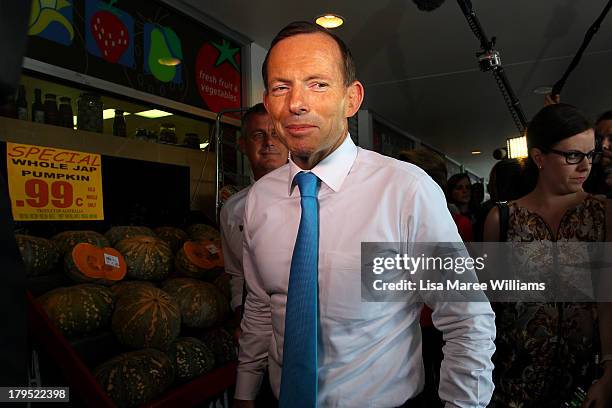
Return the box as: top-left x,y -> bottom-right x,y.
220,103 -> 288,337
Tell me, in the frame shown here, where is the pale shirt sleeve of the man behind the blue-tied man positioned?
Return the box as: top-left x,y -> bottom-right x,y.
219,205 -> 244,310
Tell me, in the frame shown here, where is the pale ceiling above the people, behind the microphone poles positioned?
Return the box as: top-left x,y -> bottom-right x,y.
191,0 -> 612,177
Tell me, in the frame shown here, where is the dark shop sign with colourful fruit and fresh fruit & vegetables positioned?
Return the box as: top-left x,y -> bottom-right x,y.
27,0 -> 242,112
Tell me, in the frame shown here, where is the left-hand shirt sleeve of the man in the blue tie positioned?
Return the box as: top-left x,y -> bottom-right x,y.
234,195 -> 272,400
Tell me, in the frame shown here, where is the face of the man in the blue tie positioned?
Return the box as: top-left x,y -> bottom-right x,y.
264,33 -> 363,169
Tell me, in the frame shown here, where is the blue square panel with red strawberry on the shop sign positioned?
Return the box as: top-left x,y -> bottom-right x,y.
86,0 -> 134,67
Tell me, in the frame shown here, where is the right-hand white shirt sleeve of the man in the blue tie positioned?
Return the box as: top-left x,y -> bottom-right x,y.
407,176 -> 495,408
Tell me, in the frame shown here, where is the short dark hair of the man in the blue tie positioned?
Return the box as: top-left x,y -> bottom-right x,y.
261,21 -> 357,89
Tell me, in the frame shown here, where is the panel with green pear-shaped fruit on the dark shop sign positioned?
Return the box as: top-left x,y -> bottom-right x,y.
144,23 -> 183,84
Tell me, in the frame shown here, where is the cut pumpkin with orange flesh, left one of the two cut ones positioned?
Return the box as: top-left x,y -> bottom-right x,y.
64,242 -> 127,286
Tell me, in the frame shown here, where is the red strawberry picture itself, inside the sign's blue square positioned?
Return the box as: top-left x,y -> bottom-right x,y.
89,0 -> 130,63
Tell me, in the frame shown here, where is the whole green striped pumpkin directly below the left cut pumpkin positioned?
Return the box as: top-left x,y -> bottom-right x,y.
38,284 -> 113,337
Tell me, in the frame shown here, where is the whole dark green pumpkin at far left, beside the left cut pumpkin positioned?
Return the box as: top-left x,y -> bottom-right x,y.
15,234 -> 59,276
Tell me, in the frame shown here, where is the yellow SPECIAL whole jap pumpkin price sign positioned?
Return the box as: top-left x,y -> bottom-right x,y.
6,143 -> 104,221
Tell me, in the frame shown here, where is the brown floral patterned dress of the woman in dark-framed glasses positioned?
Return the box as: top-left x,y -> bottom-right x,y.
490,195 -> 606,408
